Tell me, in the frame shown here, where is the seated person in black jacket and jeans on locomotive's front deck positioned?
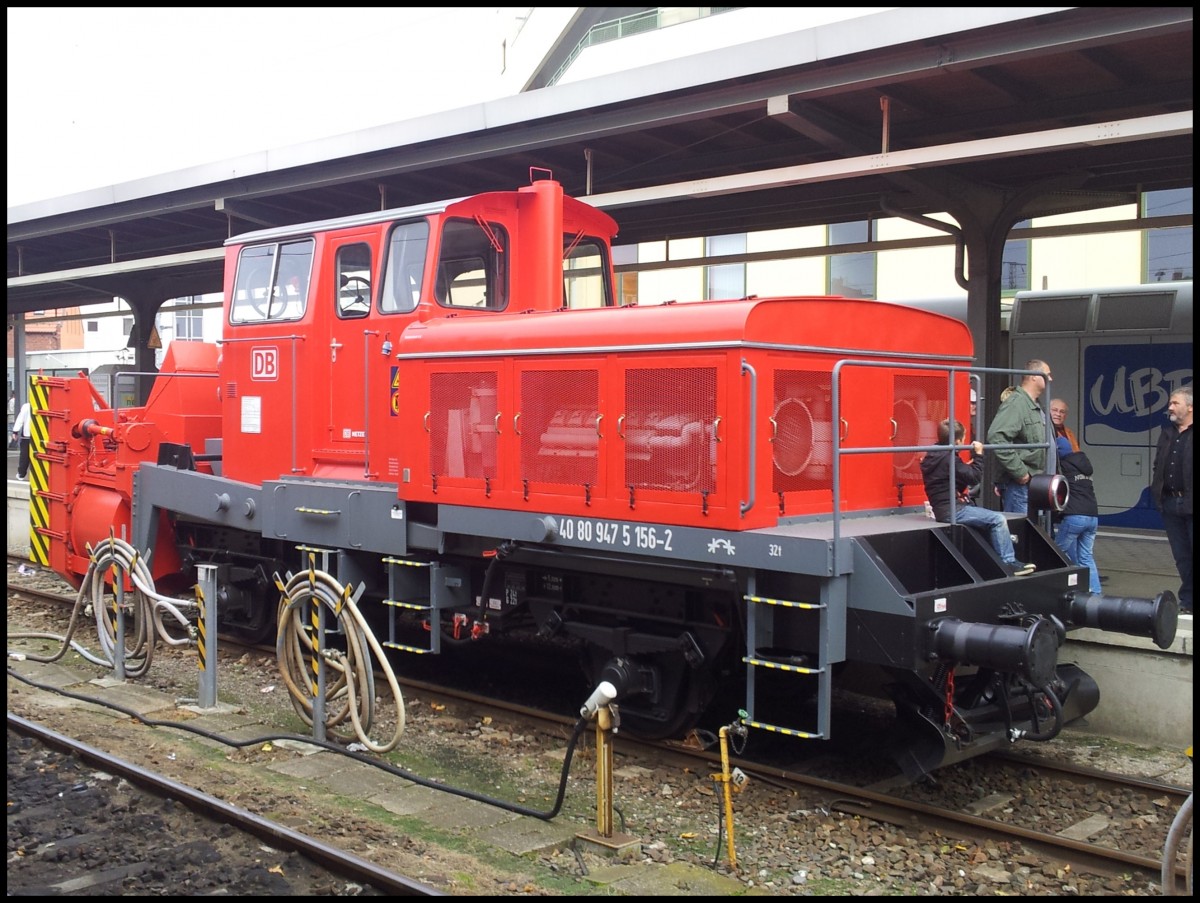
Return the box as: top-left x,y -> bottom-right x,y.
920,420 -> 1036,576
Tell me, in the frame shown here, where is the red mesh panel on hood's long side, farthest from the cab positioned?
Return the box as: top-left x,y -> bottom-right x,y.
623,367 -> 716,492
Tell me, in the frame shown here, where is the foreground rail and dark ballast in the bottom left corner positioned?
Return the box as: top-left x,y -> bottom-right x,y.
7,713 -> 442,897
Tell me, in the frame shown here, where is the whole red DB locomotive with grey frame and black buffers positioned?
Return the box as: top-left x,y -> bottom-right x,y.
23,170 -> 1177,773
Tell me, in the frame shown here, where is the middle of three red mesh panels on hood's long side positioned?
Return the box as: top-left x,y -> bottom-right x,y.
517,370 -> 602,485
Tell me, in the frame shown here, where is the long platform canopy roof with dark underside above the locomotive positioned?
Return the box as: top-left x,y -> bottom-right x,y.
7,7 -> 1193,312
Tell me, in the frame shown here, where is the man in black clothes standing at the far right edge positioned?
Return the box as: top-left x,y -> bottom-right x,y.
1150,385 -> 1194,615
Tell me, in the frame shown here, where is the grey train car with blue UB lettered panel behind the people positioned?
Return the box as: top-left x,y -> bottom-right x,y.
1009,281 -> 1194,530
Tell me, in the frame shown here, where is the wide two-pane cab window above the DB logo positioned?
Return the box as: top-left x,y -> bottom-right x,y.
229,239 -> 314,323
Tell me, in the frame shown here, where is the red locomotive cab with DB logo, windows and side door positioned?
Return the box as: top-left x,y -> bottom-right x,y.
222,180 -> 616,483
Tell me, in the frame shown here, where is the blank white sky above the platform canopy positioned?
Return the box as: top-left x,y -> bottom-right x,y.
7,6 -> 517,207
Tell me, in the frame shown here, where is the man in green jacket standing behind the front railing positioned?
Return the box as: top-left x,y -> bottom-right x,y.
988,360 -> 1050,514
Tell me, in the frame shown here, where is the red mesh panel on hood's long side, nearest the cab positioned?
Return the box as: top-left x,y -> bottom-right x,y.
428,371 -> 498,479
